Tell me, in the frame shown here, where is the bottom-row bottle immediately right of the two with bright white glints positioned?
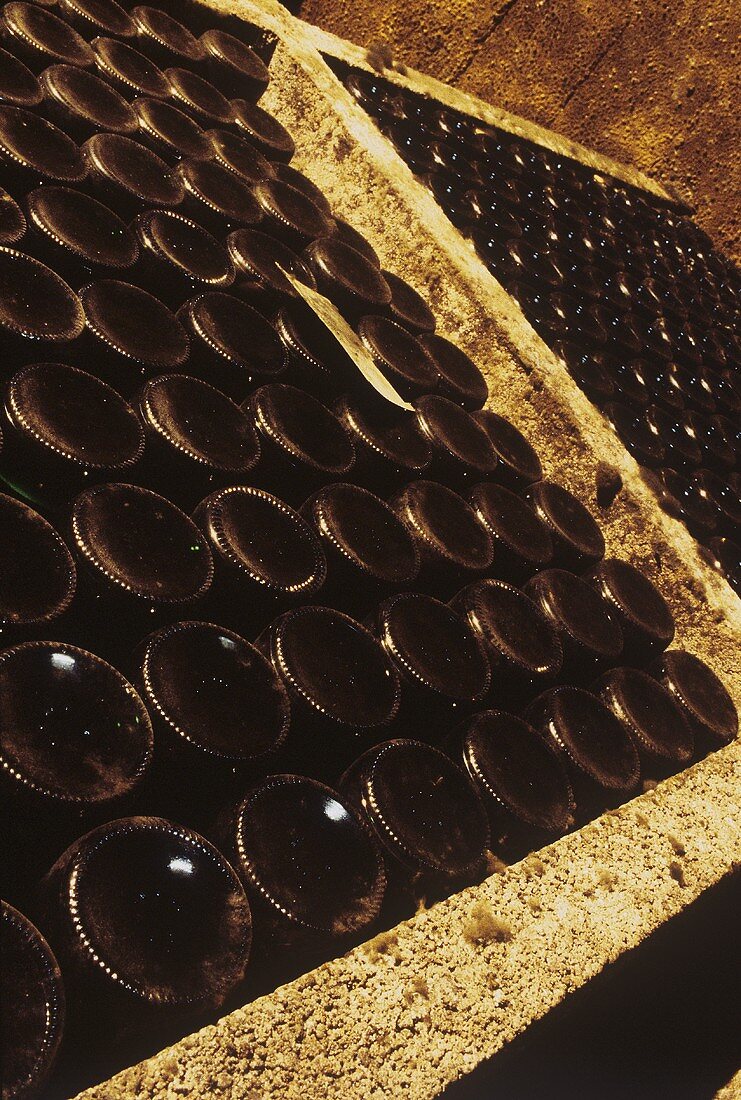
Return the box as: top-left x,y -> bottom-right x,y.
339,738 -> 489,917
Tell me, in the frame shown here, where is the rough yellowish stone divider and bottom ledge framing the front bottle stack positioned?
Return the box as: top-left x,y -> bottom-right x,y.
73,3 -> 741,1100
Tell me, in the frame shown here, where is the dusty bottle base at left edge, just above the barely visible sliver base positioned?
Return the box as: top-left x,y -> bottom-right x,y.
0,107 -> 87,195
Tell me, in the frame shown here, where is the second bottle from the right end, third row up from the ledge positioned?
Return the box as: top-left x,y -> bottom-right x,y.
468,482 -> 553,584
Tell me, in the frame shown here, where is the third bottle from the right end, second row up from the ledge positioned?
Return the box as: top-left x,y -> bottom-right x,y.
451,580 -> 563,706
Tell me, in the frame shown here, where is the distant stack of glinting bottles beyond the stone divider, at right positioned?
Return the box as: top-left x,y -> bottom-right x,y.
338,65 -> 741,592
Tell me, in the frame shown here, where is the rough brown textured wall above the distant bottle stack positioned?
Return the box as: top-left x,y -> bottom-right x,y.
300,0 -> 741,263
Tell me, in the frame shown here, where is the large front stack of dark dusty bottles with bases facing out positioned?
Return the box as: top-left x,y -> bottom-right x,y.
0,10 -> 738,1100
